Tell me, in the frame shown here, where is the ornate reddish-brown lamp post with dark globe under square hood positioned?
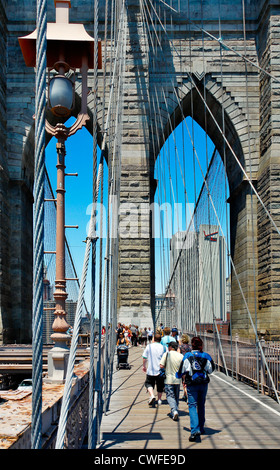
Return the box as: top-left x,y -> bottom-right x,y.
19,0 -> 101,383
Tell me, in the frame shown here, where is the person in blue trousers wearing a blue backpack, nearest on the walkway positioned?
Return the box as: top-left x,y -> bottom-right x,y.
176,336 -> 215,442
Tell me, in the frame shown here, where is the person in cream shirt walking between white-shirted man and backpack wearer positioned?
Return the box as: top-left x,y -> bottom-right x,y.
160,341 -> 184,421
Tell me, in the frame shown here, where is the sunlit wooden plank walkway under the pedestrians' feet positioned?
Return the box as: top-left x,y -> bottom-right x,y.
98,346 -> 280,451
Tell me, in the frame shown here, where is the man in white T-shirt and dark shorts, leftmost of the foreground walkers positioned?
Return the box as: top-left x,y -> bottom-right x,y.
143,334 -> 164,406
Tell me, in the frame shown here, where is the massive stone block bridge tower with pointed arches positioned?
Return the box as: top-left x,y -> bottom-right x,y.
0,0 -> 280,343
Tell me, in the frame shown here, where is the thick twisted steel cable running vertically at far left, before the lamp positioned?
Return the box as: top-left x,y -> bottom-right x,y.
31,0 -> 47,449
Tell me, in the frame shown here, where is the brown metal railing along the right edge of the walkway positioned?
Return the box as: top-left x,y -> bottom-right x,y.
189,333 -> 280,399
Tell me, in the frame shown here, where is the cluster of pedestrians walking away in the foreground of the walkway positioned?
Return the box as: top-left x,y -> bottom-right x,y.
143,327 -> 214,441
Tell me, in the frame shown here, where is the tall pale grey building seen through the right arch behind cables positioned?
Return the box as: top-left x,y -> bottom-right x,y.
170,224 -> 227,330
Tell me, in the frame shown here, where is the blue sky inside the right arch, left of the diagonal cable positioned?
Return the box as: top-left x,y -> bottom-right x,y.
155,117 -> 217,293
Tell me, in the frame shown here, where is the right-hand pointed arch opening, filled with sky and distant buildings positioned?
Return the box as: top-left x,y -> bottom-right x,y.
153,107 -> 231,331
